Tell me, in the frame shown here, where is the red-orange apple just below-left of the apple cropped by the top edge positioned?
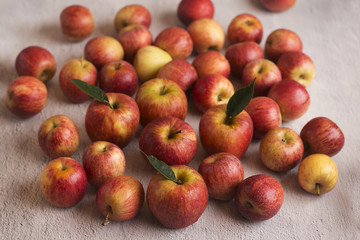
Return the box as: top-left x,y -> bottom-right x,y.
227,13 -> 263,44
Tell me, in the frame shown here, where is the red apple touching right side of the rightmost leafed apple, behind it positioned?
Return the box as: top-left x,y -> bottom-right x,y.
245,96 -> 282,138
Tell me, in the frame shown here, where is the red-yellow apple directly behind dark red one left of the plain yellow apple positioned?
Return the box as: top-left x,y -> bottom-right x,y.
84,36 -> 124,70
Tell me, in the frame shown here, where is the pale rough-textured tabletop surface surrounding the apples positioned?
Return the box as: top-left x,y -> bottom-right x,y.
0,0 -> 360,239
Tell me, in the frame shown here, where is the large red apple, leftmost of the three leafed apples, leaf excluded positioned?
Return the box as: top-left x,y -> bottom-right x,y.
85,93 -> 140,148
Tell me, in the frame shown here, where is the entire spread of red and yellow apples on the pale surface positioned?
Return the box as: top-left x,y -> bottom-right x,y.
6,0 -> 344,228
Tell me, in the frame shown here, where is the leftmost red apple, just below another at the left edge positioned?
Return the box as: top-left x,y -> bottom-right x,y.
5,76 -> 47,118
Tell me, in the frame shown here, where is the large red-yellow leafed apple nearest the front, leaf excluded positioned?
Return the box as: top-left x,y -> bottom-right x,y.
146,165 -> 208,228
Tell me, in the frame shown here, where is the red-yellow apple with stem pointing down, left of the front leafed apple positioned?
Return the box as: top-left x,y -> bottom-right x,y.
96,175 -> 145,221
